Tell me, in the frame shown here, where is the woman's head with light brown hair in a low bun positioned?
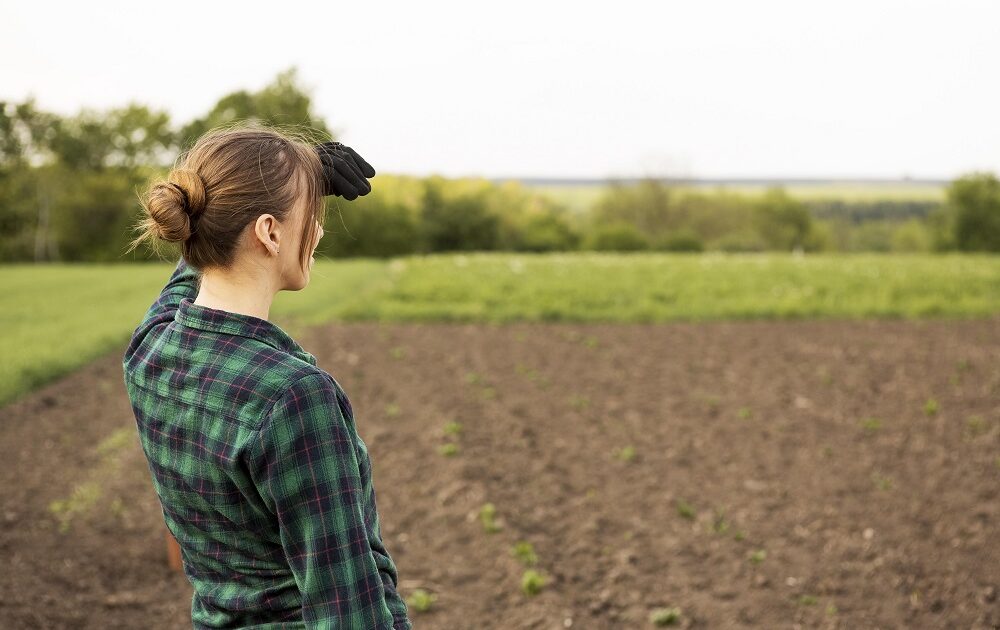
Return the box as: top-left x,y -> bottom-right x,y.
129,124 -> 325,288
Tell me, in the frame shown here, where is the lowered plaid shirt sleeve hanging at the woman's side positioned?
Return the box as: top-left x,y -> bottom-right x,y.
251,373 -> 411,630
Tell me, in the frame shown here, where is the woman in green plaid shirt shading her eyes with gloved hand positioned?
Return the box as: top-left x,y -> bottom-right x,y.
122,127 -> 412,629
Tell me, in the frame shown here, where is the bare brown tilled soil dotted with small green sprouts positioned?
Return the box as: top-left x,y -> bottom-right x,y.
0,319 -> 1000,629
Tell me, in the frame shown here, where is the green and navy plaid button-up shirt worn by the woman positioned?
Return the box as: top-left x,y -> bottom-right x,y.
122,258 -> 412,630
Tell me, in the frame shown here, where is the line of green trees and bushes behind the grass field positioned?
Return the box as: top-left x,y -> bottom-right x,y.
0,68 -> 1000,262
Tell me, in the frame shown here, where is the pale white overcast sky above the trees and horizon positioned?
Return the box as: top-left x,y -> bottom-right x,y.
0,0 -> 1000,178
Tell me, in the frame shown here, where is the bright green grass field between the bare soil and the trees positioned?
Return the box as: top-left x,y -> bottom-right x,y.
0,253 -> 1000,402
